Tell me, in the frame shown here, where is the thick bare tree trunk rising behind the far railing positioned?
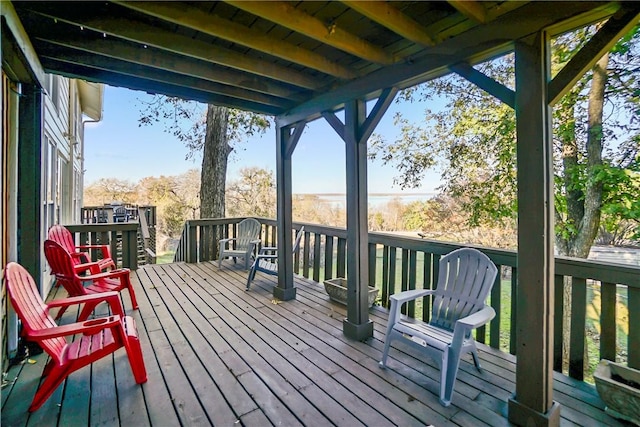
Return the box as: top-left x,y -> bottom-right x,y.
200,105 -> 231,259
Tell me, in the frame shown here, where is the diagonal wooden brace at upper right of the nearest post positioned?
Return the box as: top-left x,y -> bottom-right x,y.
549,3 -> 640,105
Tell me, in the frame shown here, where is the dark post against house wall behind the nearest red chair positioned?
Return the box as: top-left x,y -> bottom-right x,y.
18,83 -> 44,293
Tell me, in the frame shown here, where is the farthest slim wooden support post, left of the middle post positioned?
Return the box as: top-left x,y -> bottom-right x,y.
273,122 -> 306,301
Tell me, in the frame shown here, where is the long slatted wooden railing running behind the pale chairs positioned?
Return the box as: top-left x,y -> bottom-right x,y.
175,218 -> 640,380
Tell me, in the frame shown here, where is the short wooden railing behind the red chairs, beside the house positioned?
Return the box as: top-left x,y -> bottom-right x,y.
65,222 -> 138,270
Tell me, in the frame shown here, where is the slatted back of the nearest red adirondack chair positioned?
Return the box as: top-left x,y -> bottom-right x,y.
5,262 -> 67,363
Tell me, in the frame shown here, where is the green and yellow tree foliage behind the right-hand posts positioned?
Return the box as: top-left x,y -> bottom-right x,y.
369,27 -> 640,252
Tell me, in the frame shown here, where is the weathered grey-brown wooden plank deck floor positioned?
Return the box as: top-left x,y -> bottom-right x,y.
2,262 -> 624,427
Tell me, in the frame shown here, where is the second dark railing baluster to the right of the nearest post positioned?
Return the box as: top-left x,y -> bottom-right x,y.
569,277 -> 587,381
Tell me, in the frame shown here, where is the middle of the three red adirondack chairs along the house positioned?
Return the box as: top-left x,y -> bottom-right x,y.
44,239 -> 138,318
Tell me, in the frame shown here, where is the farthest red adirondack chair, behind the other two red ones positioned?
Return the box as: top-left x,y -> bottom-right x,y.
48,225 -> 116,274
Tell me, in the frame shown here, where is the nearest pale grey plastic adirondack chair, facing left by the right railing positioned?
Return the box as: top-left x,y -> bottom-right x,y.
380,248 -> 498,406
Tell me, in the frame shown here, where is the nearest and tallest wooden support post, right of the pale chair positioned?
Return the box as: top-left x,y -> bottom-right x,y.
509,32 -> 560,426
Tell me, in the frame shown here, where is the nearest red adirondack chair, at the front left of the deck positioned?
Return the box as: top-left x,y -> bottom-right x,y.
5,262 -> 147,412
